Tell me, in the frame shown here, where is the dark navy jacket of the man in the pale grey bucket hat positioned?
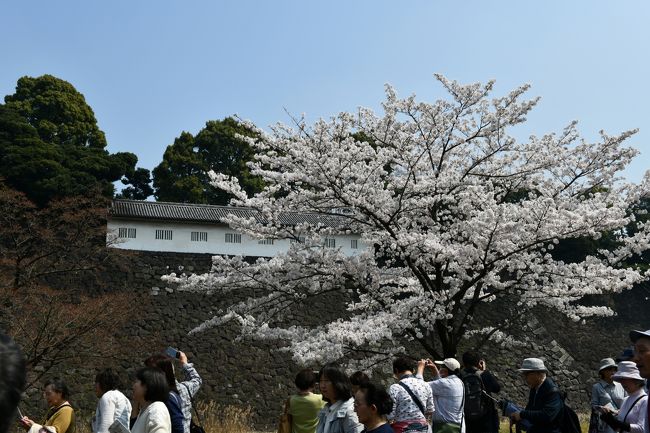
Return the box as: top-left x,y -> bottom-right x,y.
520,377 -> 564,433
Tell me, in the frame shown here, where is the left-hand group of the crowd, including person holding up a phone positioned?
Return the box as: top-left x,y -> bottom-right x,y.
0,334 -> 202,433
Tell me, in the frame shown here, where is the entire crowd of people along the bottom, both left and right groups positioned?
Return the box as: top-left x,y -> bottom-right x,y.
0,330 -> 650,433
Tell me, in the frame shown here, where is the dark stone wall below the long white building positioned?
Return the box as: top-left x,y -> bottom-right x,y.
19,248 -> 650,428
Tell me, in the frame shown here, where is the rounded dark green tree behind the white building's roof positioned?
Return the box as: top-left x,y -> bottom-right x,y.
153,117 -> 263,205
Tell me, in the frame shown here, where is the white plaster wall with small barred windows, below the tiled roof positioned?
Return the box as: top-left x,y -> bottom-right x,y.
107,218 -> 365,257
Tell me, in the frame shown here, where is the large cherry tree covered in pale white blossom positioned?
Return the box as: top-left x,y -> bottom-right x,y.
165,75 -> 650,366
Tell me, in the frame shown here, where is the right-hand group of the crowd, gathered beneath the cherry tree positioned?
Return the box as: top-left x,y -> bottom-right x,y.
285,330 -> 650,433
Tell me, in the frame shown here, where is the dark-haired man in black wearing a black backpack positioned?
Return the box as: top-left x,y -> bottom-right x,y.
461,351 -> 501,433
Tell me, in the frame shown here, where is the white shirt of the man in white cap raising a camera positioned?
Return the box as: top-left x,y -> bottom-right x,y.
418,374 -> 465,433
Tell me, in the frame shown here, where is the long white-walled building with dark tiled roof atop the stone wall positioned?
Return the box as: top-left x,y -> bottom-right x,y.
107,199 -> 365,257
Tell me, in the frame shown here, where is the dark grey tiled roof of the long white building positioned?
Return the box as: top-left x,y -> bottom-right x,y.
110,199 -> 347,227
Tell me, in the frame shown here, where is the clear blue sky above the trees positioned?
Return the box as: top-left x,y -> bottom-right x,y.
0,0 -> 650,182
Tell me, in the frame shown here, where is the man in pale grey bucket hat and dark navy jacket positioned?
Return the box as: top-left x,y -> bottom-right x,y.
511,358 -> 564,433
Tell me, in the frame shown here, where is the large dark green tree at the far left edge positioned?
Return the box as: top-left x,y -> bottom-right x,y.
0,75 -> 137,206
